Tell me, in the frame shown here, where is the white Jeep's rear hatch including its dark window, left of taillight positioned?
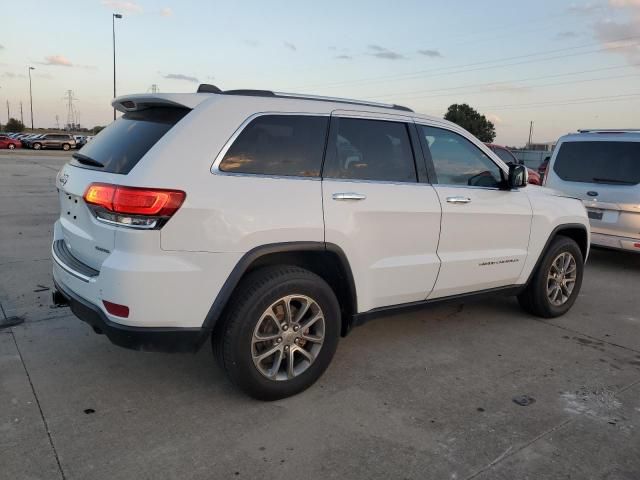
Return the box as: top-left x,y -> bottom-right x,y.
56,106 -> 190,271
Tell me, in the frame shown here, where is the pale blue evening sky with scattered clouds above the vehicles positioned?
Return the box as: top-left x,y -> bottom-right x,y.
0,0 -> 640,146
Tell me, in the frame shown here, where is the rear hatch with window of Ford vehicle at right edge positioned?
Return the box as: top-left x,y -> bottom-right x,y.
550,139 -> 640,238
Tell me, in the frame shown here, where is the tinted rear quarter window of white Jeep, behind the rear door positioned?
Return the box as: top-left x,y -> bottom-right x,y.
220,115 -> 329,177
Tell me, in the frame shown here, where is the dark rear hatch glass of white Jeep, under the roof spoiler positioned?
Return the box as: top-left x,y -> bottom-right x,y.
72,107 -> 190,174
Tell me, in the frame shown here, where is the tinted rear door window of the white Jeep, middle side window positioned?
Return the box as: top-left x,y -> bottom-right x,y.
323,118 -> 417,182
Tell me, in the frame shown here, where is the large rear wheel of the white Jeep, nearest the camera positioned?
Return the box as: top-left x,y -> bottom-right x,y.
212,265 -> 340,400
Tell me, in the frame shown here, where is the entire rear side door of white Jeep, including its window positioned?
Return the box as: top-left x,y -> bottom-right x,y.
322,112 -> 441,312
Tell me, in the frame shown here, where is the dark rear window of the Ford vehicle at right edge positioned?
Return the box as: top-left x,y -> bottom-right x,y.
553,142 -> 640,185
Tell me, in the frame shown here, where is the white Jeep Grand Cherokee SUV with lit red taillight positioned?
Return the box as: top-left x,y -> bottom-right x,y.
52,85 -> 589,399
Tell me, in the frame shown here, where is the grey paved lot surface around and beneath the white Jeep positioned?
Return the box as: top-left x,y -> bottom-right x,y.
0,152 -> 640,480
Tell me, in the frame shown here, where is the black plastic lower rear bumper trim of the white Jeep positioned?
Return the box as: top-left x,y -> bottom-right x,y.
54,282 -> 201,353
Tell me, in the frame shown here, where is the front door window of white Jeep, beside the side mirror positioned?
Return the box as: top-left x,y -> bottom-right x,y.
418,125 -> 502,188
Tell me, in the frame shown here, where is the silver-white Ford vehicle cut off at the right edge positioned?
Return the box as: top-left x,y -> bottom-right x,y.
544,130 -> 640,253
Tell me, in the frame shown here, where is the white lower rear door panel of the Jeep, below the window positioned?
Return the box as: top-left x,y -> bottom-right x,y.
322,179 -> 440,312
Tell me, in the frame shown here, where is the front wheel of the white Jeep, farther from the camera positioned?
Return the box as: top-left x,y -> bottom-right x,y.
518,235 -> 584,318
